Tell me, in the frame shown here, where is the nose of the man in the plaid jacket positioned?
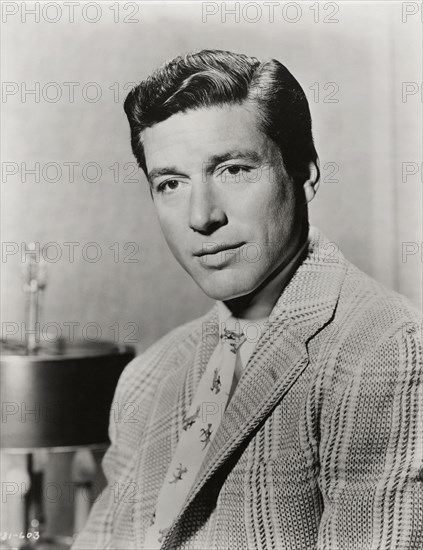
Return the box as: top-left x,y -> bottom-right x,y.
189,181 -> 228,235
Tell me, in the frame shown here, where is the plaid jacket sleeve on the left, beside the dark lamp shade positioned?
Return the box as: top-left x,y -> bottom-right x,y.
71,355 -> 146,550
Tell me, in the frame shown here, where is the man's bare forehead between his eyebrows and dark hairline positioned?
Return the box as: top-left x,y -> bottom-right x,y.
141,103 -> 275,169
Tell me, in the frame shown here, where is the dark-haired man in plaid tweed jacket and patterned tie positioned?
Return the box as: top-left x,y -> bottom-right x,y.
74,50 -> 423,550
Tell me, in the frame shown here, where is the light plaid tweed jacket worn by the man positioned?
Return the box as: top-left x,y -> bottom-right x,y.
73,231 -> 423,550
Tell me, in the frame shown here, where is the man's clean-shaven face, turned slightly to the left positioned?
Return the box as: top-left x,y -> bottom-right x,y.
142,103 -> 301,300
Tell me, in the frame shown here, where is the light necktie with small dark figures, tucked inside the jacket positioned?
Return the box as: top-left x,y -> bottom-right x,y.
144,317 -> 246,550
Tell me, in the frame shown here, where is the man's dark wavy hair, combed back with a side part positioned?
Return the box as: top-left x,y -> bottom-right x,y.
124,50 -> 319,185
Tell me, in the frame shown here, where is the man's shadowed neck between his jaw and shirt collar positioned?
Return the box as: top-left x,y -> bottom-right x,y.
225,231 -> 308,320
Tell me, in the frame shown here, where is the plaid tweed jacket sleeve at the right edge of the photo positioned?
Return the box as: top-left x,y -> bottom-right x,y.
317,323 -> 423,550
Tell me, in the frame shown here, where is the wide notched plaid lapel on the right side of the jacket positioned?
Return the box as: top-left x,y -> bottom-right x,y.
162,230 -> 346,550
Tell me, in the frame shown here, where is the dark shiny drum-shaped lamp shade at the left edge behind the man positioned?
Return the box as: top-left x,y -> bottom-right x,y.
0,341 -> 135,451
